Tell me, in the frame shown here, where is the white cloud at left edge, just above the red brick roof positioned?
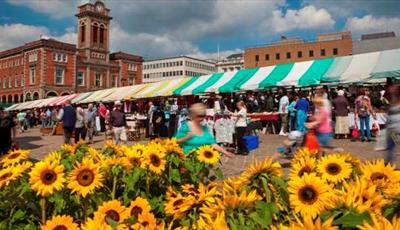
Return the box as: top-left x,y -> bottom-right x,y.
0,23 -> 49,50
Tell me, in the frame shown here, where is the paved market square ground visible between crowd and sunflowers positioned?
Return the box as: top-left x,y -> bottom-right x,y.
18,128 -> 400,176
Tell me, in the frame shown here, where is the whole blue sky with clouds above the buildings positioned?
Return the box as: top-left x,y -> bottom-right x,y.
0,0 -> 400,59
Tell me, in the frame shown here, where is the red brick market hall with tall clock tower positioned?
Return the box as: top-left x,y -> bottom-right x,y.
0,1 -> 143,103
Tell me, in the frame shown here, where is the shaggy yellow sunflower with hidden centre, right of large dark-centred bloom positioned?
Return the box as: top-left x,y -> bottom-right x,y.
341,178 -> 389,216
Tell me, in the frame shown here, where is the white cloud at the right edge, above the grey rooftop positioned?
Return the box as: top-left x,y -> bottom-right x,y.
346,15 -> 400,36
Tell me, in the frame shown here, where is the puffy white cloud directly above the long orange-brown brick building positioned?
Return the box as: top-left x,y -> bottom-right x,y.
268,5 -> 335,32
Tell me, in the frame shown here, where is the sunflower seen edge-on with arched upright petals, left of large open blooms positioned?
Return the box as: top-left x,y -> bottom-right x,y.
240,157 -> 283,183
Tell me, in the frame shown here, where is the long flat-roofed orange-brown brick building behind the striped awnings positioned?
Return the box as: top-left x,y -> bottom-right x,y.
244,31 -> 352,68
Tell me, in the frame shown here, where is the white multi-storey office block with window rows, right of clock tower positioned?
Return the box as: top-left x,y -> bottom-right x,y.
143,56 -> 216,83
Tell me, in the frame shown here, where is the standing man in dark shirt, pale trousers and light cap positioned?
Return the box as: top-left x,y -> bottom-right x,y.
110,101 -> 127,144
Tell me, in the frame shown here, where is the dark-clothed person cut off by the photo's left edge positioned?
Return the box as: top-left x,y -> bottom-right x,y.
0,107 -> 17,155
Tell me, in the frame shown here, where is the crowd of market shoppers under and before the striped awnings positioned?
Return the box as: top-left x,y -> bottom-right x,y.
0,85 -> 400,164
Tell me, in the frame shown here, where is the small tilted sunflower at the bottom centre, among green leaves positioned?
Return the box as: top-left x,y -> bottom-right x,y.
164,194 -> 195,219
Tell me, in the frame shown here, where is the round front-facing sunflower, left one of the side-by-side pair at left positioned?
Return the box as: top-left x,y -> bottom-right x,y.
29,161 -> 65,196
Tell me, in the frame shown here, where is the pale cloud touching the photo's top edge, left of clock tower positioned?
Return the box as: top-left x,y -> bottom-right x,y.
8,0 -> 78,19
